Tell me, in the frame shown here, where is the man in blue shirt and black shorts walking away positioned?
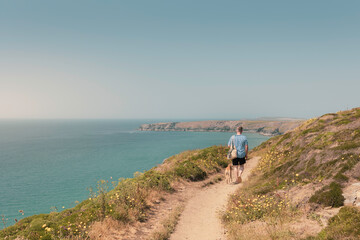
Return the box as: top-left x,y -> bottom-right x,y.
228,127 -> 249,183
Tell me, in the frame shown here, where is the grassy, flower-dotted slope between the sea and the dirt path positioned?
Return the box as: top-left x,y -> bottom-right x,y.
0,146 -> 227,240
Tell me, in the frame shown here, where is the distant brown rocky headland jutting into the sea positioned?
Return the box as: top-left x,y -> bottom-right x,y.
139,120 -> 303,136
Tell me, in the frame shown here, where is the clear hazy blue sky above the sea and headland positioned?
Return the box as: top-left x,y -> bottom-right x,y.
0,0 -> 360,119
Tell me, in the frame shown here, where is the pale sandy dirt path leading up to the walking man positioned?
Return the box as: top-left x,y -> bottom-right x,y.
170,157 -> 259,240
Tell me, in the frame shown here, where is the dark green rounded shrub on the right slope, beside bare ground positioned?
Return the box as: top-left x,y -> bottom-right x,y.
309,182 -> 345,207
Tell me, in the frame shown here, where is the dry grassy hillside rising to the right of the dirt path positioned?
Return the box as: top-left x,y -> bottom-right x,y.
223,108 -> 360,240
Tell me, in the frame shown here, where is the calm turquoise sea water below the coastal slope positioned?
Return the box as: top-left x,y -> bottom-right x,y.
0,120 -> 268,229
